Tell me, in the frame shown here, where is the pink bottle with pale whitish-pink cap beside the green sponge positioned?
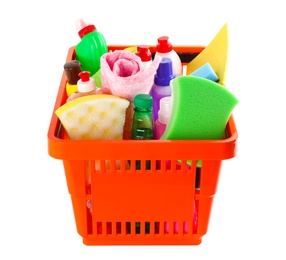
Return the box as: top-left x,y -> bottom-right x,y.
155,96 -> 173,140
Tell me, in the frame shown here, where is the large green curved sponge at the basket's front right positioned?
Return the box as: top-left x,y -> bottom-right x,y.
161,76 -> 238,140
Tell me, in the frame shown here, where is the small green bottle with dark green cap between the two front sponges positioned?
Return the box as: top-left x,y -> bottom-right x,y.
131,94 -> 154,170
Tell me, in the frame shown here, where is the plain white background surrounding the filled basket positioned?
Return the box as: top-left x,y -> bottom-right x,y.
0,0 -> 286,260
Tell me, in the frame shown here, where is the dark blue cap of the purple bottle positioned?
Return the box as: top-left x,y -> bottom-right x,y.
154,57 -> 175,86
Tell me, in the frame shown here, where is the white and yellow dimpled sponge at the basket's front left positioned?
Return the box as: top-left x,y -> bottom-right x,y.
55,94 -> 129,140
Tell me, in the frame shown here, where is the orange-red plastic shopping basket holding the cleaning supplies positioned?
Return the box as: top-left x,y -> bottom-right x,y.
48,46 -> 238,245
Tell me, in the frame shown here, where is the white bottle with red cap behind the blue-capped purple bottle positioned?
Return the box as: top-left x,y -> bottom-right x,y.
155,36 -> 183,77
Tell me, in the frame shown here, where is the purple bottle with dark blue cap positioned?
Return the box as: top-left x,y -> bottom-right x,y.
151,57 -> 175,122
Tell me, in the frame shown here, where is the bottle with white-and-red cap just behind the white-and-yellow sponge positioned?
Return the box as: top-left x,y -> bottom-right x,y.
67,71 -> 97,102
